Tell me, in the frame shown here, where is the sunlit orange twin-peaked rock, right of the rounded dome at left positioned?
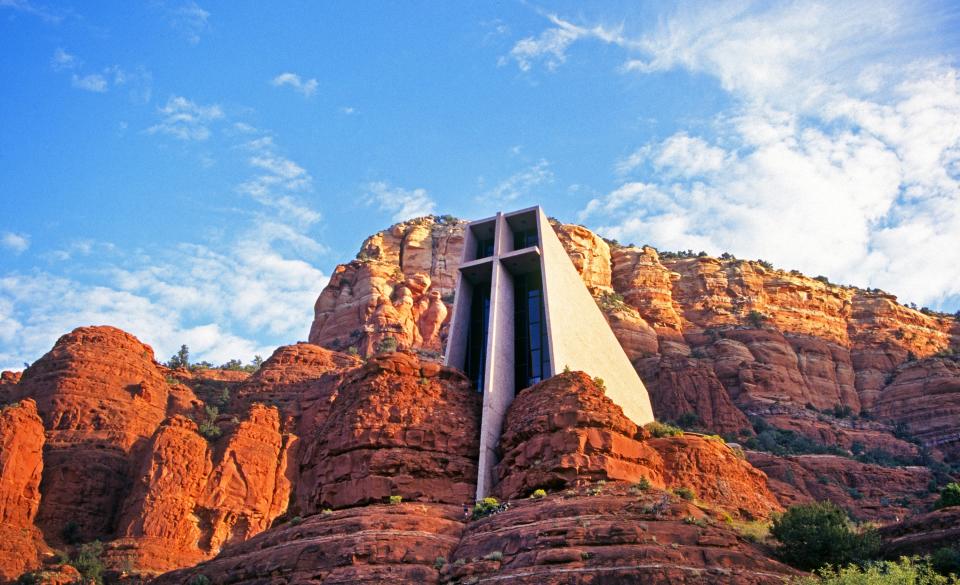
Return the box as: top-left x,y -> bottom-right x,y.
109,404 -> 293,572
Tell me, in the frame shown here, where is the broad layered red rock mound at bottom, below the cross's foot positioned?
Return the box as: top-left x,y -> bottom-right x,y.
444,488 -> 796,585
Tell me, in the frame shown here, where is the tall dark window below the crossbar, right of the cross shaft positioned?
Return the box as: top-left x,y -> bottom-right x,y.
514,270 -> 550,392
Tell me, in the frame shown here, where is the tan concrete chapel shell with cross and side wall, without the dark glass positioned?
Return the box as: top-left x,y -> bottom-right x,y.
445,207 -> 653,499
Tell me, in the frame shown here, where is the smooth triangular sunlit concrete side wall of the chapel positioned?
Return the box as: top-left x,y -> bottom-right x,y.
538,210 -> 653,425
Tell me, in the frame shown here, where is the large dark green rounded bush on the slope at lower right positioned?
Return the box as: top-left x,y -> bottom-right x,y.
770,502 -> 880,571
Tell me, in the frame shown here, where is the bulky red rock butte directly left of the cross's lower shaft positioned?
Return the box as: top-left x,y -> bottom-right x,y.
297,353 -> 480,514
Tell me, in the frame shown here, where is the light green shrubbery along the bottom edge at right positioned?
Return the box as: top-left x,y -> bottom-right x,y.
794,557 -> 960,585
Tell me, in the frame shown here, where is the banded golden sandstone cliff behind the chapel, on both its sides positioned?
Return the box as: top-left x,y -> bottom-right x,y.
310,217 -> 960,456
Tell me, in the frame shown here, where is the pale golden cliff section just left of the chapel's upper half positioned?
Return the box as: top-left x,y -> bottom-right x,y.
309,216 -> 464,357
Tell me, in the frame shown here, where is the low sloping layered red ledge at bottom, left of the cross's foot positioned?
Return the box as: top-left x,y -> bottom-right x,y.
153,503 -> 463,585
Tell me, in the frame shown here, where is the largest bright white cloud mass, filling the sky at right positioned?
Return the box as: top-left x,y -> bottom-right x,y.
568,2 -> 960,307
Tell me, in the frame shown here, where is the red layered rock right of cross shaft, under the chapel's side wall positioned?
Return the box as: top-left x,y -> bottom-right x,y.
495,372 -> 781,518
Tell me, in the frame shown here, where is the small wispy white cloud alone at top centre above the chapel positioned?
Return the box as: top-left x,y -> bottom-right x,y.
500,14 -> 633,71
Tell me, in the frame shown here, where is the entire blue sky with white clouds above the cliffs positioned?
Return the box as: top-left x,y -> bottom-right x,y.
0,0 -> 960,368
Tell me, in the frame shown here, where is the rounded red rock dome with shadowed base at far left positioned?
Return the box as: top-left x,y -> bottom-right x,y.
18,327 -> 169,541
